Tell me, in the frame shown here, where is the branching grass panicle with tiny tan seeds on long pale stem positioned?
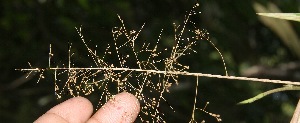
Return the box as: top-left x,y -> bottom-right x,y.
16,3 -> 300,122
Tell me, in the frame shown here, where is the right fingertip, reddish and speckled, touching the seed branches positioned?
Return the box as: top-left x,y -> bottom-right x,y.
88,92 -> 140,123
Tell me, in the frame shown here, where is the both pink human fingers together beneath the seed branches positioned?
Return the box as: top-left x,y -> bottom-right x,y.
35,92 -> 140,123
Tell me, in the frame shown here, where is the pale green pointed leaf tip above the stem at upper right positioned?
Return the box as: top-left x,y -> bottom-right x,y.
257,13 -> 300,22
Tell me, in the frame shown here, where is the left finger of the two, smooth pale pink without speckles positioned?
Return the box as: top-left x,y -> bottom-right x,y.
35,97 -> 93,123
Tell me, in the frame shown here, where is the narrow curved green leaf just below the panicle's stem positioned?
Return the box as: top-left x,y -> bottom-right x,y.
238,85 -> 300,105
